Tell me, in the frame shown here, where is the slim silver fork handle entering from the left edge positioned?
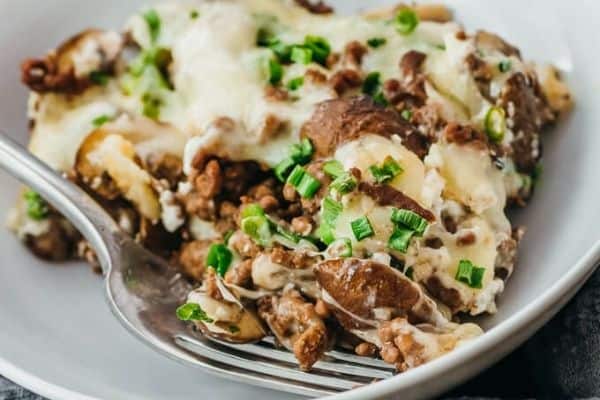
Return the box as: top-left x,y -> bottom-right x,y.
0,132 -> 121,273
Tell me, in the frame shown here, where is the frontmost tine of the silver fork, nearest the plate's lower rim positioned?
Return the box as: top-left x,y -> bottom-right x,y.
175,335 -> 371,391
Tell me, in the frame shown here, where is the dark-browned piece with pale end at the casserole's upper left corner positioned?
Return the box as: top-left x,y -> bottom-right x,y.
21,29 -> 123,94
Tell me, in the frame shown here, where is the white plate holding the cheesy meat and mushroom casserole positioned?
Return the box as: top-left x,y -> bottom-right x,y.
0,0 -> 600,400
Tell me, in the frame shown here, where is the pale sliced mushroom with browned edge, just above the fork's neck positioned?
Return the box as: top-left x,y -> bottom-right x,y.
75,129 -> 160,221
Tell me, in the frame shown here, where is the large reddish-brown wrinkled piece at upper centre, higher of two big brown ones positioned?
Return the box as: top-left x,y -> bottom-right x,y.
301,96 -> 413,157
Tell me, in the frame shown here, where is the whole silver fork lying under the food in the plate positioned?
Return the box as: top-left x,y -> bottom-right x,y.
0,133 -> 394,396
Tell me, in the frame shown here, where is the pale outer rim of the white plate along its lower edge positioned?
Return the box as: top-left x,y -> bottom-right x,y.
0,239 -> 600,400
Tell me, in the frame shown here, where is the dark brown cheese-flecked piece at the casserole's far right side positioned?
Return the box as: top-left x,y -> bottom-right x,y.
498,72 -> 554,174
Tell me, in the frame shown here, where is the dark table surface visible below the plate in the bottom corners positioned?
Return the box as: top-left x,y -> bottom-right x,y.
0,269 -> 600,400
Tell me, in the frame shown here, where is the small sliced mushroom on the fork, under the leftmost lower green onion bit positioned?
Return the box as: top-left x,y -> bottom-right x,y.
188,275 -> 265,343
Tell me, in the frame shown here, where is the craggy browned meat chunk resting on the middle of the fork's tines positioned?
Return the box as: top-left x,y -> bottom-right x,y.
258,290 -> 328,370
